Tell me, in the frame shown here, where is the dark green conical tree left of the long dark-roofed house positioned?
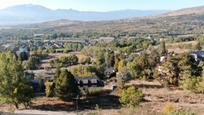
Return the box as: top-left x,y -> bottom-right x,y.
55,70 -> 79,100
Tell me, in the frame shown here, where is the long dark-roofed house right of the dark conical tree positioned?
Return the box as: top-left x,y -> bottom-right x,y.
76,76 -> 104,87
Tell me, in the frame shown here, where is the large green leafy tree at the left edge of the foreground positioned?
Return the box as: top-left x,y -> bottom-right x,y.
0,52 -> 34,108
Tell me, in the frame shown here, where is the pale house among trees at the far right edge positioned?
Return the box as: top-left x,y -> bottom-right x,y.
190,50 -> 204,62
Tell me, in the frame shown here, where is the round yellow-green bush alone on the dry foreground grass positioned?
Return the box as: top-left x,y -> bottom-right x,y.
120,86 -> 144,107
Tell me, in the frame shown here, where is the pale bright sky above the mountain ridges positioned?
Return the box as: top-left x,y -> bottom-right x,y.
0,0 -> 204,11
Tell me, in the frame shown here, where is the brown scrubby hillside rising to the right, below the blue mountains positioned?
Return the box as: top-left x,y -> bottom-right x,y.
0,7 -> 204,36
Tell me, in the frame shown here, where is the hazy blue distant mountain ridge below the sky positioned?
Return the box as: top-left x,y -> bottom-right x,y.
0,4 -> 167,25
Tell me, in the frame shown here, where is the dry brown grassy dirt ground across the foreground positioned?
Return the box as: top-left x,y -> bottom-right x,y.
0,81 -> 204,115
